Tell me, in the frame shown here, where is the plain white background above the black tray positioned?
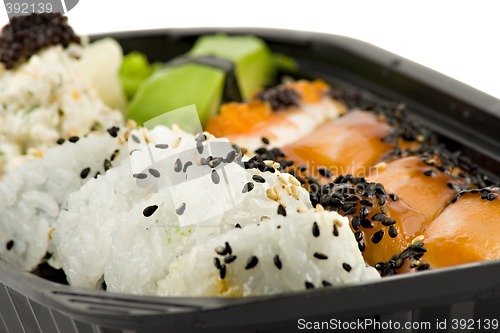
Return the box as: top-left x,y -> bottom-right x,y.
0,0 -> 500,98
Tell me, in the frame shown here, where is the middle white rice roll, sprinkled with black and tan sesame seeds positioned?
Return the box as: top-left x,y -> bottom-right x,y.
53,126 -> 311,295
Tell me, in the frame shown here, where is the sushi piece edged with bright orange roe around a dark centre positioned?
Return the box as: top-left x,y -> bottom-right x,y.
206,80 -> 346,152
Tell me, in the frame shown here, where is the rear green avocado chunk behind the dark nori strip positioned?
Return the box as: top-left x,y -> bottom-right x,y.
189,34 -> 275,99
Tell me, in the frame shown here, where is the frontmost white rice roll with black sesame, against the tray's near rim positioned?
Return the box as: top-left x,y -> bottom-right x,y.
158,209 -> 380,297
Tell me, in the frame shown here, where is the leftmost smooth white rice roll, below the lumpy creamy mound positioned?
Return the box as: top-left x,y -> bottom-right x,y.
0,128 -> 131,270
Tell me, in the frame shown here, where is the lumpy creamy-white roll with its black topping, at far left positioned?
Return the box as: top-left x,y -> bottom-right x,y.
0,14 -> 123,174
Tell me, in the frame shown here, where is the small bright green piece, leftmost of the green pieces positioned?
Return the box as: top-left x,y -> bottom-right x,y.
119,51 -> 162,100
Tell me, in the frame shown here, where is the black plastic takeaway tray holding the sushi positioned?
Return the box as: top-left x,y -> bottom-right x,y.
0,29 -> 500,333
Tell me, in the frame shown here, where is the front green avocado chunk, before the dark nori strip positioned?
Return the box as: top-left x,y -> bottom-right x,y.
127,64 -> 224,124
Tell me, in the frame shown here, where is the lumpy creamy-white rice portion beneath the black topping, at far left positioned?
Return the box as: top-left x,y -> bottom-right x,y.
0,45 -> 123,177
